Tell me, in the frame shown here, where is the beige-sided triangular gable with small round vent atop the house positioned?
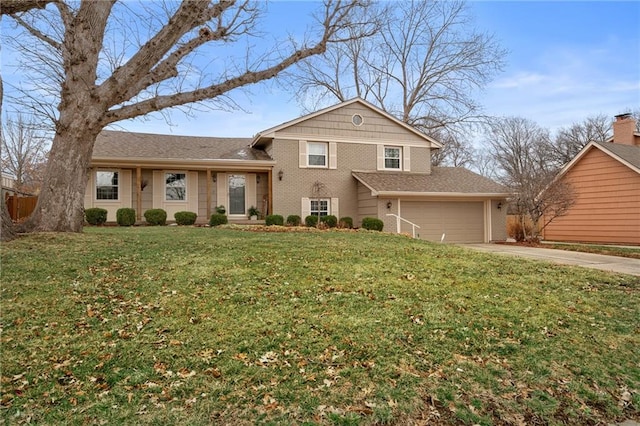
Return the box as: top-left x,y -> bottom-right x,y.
252,98 -> 442,148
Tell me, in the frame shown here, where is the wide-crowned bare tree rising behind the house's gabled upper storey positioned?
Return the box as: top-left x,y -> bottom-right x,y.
293,1 -> 506,133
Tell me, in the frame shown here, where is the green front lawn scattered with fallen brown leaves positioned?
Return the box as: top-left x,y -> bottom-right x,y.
0,227 -> 640,425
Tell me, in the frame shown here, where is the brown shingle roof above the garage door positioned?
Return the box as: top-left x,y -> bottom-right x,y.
352,167 -> 509,195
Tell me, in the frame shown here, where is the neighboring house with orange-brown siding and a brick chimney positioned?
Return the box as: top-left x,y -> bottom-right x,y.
544,114 -> 640,245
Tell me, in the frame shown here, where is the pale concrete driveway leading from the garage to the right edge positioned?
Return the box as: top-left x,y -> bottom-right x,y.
462,244 -> 640,276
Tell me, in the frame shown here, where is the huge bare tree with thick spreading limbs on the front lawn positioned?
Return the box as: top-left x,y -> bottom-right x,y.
3,0 -> 370,232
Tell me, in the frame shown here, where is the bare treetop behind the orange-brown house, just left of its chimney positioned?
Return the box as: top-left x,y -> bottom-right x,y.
551,114 -> 611,164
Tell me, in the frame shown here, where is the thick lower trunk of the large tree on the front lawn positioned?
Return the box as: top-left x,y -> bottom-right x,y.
26,126 -> 98,232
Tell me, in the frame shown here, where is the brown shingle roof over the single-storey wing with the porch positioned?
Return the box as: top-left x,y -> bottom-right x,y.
93,130 -> 272,161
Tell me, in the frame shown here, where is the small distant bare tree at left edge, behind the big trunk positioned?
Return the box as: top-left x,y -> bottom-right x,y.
0,114 -> 48,192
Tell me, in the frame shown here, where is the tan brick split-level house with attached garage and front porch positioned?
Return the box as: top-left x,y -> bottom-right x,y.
85,98 -> 509,242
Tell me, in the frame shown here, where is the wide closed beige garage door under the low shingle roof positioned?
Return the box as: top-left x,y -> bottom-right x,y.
400,201 -> 484,243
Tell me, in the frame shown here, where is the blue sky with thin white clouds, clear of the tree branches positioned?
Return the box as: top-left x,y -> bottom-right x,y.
3,1 -> 640,137
